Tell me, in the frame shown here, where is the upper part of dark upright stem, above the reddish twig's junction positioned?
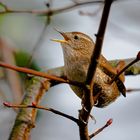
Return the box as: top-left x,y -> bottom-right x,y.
86,0 -> 113,88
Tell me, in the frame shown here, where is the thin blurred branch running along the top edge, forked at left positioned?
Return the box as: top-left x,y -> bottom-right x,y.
0,0 -> 104,16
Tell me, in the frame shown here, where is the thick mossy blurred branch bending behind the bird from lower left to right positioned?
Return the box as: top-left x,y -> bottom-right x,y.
0,58 -> 140,140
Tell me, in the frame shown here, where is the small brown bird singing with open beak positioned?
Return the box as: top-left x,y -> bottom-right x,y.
53,31 -> 126,107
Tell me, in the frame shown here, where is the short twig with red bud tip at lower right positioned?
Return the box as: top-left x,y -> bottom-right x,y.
89,119 -> 113,139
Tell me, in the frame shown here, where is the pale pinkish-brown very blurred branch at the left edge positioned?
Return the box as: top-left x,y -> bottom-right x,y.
0,38 -> 23,103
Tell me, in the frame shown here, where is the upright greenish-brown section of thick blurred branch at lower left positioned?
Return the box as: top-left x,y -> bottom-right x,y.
9,77 -> 51,140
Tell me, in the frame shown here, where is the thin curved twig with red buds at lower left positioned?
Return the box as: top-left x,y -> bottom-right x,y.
3,102 -> 80,124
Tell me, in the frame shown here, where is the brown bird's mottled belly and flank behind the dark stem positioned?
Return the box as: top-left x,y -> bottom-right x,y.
65,65 -> 120,107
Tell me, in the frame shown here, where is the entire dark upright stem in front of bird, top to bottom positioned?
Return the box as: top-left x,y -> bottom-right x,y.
79,0 -> 113,140
